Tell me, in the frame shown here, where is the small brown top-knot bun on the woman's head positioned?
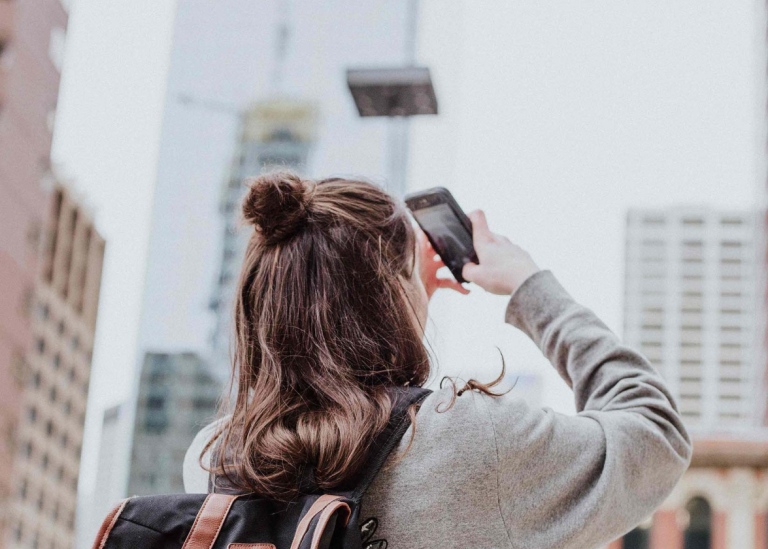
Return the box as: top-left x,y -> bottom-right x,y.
243,172 -> 311,245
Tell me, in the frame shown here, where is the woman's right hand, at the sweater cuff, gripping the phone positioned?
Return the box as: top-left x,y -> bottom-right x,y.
461,210 -> 540,295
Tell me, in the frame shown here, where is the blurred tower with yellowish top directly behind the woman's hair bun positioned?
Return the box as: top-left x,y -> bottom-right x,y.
210,99 -> 316,372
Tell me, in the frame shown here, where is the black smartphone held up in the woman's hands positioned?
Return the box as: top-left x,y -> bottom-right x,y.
405,187 -> 477,282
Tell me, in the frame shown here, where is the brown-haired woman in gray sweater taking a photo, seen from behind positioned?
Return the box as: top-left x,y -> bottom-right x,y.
184,173 -> 691,549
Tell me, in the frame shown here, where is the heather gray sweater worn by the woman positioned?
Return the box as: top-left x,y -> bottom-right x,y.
184,270 -> 691,549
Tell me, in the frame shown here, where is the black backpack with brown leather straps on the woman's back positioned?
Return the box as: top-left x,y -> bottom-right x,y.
93,387 -> 431,549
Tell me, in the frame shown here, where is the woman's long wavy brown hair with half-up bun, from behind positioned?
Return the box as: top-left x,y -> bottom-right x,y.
207,172 -> 429,500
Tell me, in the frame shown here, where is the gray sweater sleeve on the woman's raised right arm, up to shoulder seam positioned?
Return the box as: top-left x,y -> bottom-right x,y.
483,270 -> 691,549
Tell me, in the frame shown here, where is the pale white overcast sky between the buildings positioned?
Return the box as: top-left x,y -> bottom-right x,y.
53,0 -> 765,524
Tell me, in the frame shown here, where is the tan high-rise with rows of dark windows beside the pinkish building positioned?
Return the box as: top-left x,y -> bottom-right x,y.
6,184 -> 104,549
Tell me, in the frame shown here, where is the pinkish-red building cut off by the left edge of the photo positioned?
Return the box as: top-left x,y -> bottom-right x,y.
0,0 -> 68,536
